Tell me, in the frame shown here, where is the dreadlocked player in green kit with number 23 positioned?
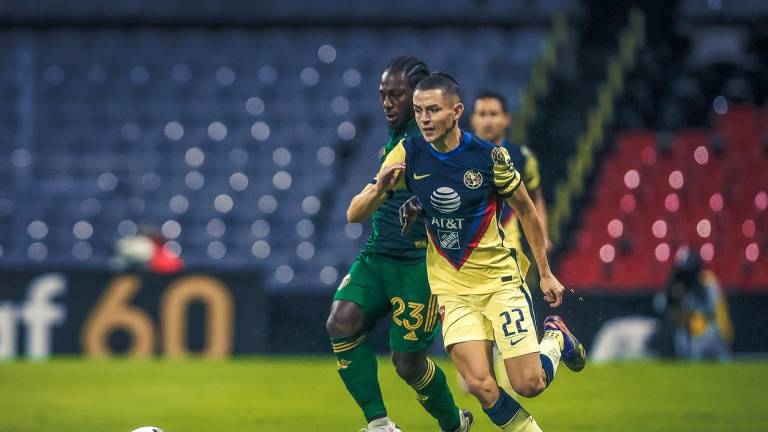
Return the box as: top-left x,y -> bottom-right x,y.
326,57 -> 473,432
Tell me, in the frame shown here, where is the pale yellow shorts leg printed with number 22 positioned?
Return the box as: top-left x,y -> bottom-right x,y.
483,286 -> 539,359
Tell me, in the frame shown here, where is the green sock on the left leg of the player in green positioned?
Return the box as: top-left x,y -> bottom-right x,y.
331,335 -> 387,422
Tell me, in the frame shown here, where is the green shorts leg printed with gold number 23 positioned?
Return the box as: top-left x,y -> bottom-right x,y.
385,263 -> 439,353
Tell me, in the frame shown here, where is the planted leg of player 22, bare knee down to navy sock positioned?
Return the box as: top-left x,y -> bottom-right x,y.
449,341 -> 541,432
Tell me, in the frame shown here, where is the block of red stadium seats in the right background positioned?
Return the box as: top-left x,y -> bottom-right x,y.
561,106 -> 768,291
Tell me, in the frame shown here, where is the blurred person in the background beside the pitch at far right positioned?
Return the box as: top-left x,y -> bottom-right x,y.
657,247 -> 733,360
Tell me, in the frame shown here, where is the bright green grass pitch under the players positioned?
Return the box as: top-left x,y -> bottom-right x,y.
0,357 -> 768,432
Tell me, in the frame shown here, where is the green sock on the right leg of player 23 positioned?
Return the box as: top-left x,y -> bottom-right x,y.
409,358 -> 461,432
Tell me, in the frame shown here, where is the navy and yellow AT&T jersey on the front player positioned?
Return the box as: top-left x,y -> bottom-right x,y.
382,132 -> 522,294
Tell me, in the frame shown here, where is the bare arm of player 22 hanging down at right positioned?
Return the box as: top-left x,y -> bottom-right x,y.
507,184 -> 563,307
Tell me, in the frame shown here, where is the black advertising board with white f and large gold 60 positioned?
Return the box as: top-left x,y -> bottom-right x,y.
0,271 -> 269,359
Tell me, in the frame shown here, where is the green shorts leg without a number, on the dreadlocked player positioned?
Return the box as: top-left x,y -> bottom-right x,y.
333,255 -> 390,324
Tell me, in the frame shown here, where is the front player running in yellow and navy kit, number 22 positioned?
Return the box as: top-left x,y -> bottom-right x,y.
370,73 -> 586,431
